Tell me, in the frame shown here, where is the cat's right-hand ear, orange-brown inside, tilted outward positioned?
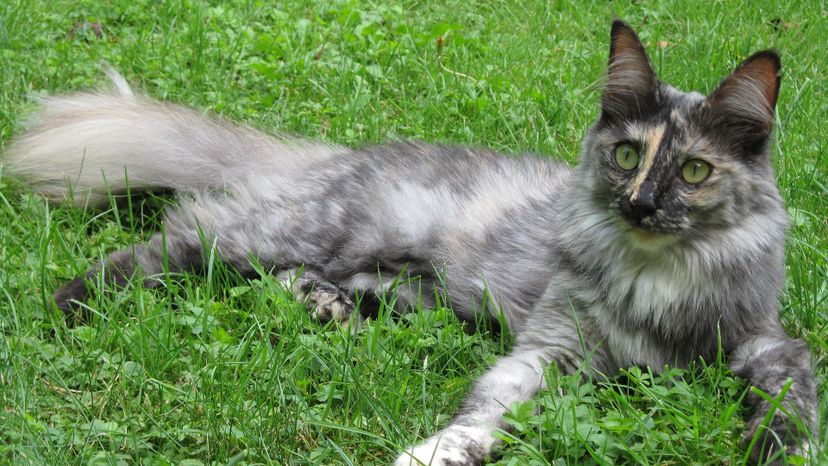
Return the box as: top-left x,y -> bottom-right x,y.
707,50 -> 782,148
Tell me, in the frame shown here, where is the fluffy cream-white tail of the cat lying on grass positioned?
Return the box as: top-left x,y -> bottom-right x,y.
0,69 -> 342,204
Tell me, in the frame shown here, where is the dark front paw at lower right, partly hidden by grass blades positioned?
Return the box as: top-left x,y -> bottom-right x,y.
745,411 -> 810,465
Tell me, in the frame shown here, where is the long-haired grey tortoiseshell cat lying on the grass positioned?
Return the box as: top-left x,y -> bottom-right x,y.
4,20 -> 817,465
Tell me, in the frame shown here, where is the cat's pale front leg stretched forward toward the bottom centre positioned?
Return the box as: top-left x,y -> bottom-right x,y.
395,334 -> 580,466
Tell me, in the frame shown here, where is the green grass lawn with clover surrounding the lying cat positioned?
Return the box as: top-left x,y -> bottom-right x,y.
0,0 -> 828,465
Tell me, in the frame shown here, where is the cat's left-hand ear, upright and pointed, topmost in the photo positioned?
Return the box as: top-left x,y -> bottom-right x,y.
601,20 -> 658,119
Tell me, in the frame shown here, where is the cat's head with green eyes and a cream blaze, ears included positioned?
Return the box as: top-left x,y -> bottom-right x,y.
580,21 -> 780,246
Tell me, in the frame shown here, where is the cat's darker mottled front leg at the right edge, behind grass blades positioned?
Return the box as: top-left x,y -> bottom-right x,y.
730,332 -> 817,464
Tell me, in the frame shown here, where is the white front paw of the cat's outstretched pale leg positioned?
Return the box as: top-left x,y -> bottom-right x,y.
394,428 -> 486,466
